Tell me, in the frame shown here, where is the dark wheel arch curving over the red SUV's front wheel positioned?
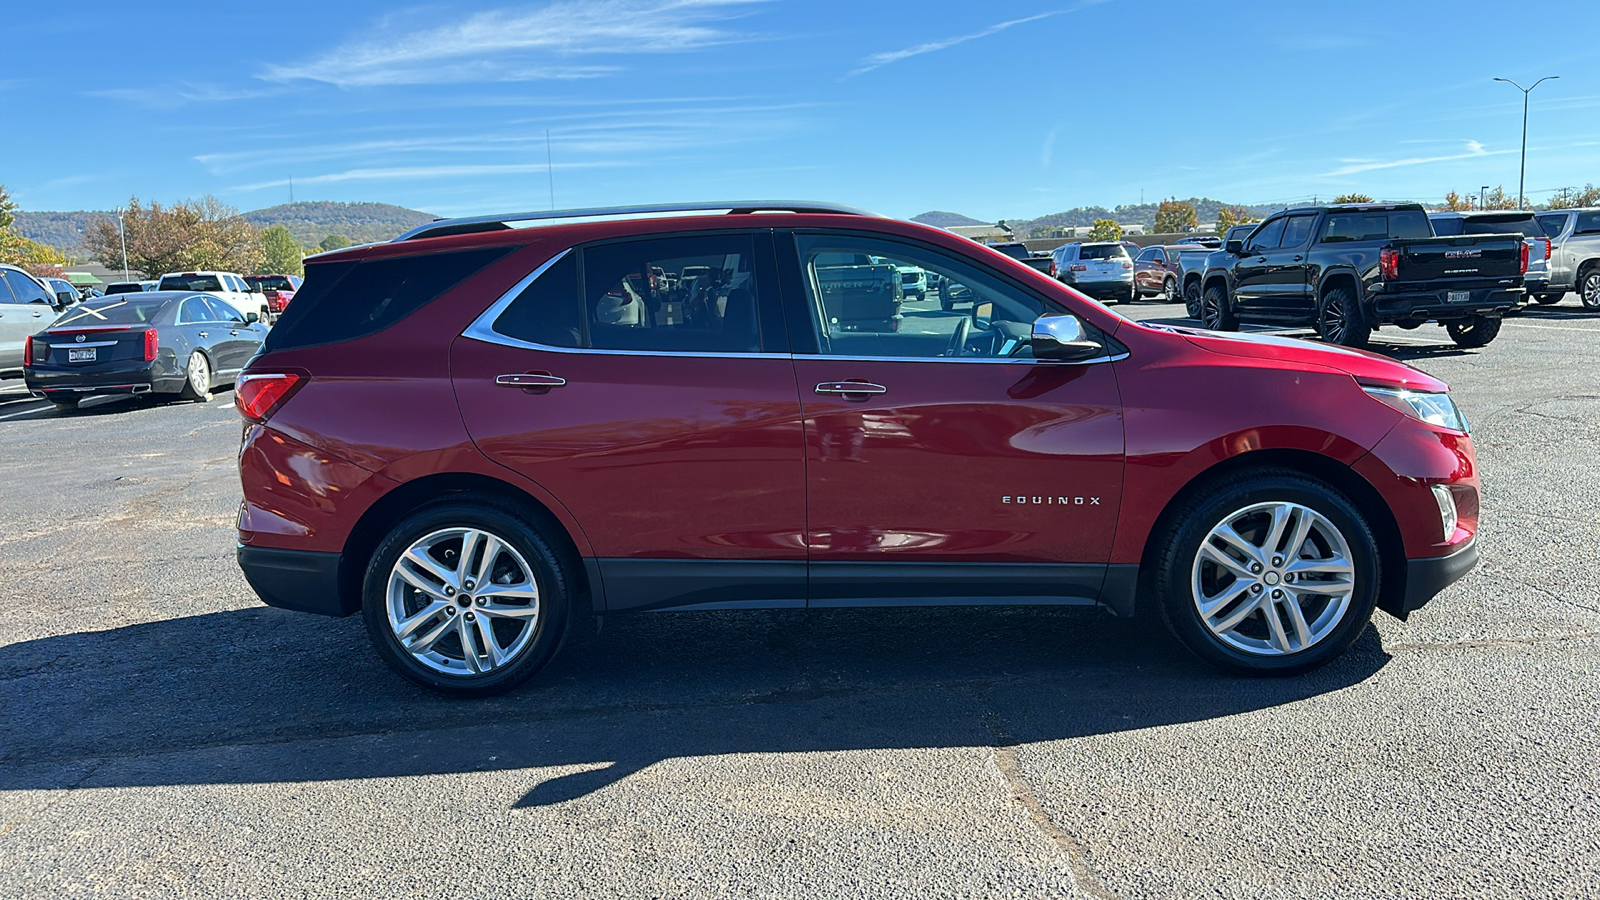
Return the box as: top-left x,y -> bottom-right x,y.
1134,448 -> 1406,613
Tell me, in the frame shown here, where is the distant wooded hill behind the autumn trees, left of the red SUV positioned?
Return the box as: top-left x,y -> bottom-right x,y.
16,202 -> 434,253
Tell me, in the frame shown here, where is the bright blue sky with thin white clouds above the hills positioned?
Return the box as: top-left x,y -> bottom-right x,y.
9,0 -> 1600,219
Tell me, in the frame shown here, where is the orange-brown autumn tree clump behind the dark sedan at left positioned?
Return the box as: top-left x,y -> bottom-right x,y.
83,195 -> 261,279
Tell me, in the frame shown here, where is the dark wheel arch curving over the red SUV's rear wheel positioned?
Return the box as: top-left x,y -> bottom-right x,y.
339,472 -> 595,613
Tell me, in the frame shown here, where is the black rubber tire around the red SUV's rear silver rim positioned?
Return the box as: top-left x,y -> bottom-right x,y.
362,495 -> 574,697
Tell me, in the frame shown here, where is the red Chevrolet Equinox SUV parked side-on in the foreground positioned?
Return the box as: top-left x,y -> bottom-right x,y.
237,203 -> 1478,695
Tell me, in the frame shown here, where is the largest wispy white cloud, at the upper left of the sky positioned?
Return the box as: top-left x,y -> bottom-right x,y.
264,0 -> 765,88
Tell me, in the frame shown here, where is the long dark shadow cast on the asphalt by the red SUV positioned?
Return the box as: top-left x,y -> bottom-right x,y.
0,607 -> 1389,806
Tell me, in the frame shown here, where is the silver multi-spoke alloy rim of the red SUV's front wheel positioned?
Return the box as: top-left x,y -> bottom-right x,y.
1190,503 -> 1355,657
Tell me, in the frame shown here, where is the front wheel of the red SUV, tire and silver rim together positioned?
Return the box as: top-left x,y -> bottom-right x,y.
1152,469 -> 1379,674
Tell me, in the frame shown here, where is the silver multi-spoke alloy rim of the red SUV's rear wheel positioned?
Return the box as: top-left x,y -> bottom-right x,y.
387,528 -> 541,676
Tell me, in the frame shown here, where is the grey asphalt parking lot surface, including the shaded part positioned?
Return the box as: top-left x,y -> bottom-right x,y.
0,296 -> 1600,897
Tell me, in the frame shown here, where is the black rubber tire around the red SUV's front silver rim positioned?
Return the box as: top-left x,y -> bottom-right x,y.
1146,468 -> 1381,676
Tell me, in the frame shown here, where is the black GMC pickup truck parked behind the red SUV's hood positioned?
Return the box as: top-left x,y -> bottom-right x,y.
1200,203 -> 1528,348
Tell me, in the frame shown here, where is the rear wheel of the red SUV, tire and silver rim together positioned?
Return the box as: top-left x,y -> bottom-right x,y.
362,500 -> 571,697
